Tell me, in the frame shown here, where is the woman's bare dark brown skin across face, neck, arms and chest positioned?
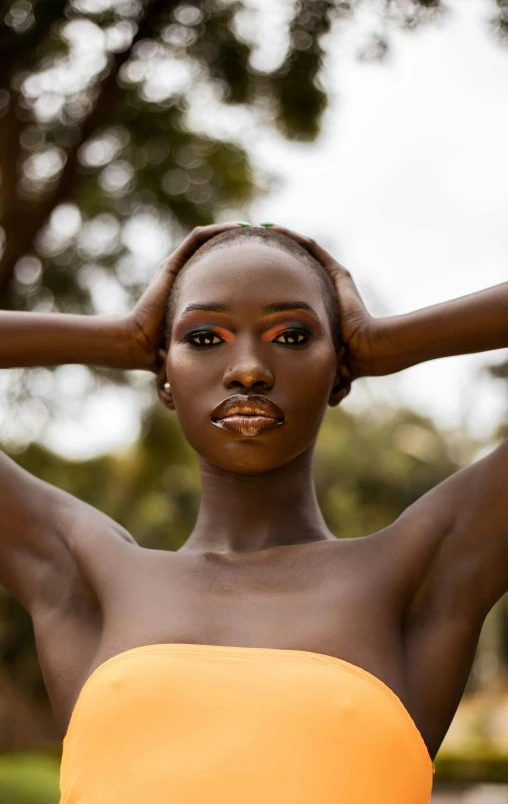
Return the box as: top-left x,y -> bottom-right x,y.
0,224 -> 508,758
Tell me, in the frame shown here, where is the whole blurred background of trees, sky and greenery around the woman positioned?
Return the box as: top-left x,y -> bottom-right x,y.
0,0 -> 508,804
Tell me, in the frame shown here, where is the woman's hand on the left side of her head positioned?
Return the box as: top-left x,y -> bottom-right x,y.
127,223 -> 239,374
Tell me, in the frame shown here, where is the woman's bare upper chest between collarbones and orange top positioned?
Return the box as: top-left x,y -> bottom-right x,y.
94,542 -> 404,696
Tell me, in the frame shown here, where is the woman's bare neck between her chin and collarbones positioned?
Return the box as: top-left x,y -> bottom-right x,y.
181,450 -> 335,554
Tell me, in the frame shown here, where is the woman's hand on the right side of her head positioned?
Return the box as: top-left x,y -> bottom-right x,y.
270,225 -> 384,396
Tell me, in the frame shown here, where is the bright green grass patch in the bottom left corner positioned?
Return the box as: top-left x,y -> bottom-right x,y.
0,754 -> 60,804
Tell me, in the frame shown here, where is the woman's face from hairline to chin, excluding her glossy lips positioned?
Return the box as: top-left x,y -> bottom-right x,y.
166,242 -> 338,474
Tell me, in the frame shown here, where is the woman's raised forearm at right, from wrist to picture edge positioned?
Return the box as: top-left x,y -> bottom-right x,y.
376,282 -> 508,374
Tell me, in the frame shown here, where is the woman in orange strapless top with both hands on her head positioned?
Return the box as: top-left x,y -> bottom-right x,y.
0,223 -> 508,804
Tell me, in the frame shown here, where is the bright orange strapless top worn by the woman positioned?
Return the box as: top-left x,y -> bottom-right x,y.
60,644 -> 433,804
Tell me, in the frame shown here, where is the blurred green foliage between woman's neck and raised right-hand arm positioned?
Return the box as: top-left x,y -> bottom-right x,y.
315,408 -> 458,538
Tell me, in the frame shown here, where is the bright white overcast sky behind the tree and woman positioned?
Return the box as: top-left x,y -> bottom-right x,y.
38,0 -> 508,458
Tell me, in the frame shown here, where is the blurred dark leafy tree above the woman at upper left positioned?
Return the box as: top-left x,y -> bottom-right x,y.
0,0 -> 346,312
